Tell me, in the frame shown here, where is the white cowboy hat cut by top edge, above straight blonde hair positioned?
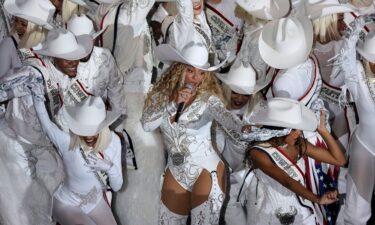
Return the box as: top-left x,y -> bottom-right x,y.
305,0 -> 357,20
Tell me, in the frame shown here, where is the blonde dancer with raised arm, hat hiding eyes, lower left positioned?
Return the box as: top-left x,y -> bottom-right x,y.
31,88 -> 123,225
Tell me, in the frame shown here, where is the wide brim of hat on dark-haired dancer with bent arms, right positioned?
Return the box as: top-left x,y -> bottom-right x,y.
249,99 -> 318,131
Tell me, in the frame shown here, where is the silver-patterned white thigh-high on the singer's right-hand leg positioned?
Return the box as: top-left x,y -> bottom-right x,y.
191,172 -> 224,225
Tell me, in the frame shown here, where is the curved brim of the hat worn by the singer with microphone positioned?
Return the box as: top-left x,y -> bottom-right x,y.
155,44 -> 229,71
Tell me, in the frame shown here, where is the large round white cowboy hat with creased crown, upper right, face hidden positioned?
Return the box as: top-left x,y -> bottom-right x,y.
259,17 -> 313,69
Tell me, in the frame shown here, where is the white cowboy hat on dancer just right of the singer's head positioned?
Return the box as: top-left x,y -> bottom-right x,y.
216,63 -> 273,95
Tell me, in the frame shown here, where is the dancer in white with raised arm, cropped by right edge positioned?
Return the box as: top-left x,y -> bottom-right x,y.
341,14 -> 375,225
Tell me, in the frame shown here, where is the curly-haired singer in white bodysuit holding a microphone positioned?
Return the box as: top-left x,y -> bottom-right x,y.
142,43 -> 247,225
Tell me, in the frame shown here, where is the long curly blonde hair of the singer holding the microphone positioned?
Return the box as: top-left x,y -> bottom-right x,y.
144,63 -> 225,109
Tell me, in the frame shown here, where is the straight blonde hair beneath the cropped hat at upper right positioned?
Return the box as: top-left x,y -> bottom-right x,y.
313,14 -> 341,44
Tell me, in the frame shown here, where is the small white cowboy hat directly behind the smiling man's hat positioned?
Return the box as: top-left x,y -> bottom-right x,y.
66,14 -> 107,39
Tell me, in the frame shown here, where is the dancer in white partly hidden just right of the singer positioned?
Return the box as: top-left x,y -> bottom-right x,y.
213,62 -> 272,225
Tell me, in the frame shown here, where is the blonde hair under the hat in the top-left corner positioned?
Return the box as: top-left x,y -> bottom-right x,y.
11,21 -> 48,48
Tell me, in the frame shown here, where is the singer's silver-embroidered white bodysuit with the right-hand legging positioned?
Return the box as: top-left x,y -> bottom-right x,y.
142,93 -> 242,224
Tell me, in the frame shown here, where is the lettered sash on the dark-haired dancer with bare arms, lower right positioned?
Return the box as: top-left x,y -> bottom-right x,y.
255,145 -> 323,225
